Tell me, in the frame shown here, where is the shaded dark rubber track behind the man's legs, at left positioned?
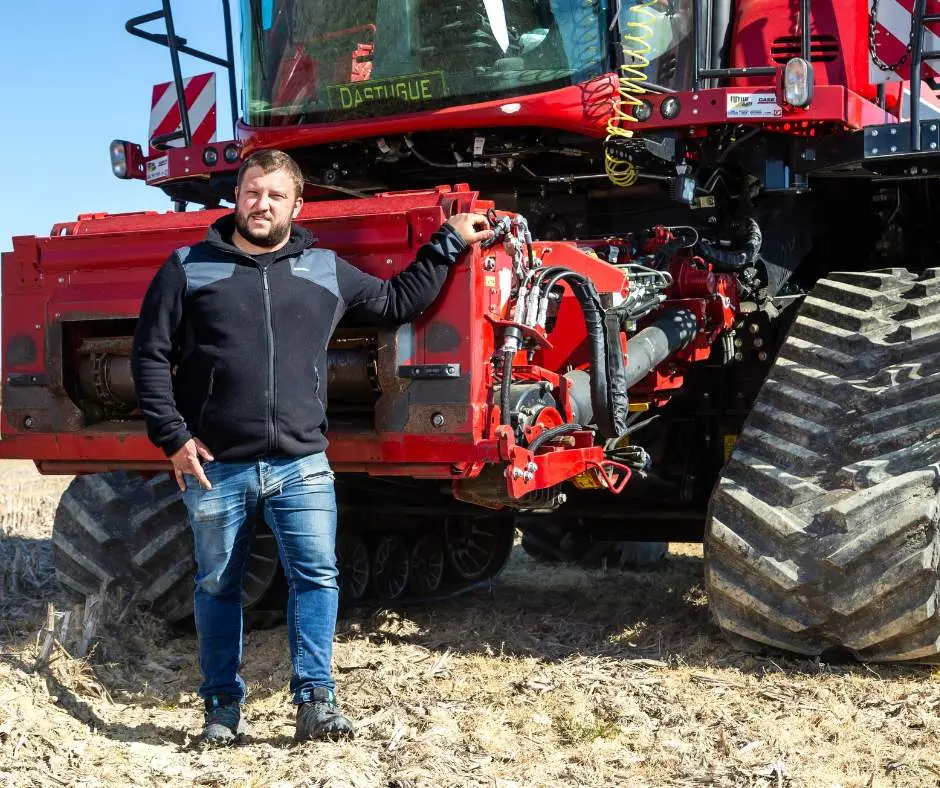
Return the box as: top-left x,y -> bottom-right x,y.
52,471 -> 280,623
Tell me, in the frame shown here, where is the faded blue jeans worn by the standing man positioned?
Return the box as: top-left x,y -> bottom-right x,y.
183,453 -> 339,703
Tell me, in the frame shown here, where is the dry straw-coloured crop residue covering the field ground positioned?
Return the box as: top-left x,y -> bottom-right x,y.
0,463 -> 940,788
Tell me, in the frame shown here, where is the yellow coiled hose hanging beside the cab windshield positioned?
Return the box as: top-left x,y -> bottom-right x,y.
604,0 -> 657,187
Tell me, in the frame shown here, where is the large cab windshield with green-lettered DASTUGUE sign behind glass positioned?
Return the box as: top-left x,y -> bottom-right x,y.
241,0 -> 615,126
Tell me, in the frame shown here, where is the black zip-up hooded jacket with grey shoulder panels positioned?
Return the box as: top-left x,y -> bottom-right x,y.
132,215 -> 467,461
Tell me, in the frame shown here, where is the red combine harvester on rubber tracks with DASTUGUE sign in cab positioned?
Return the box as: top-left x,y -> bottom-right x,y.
0,0 -> 940,661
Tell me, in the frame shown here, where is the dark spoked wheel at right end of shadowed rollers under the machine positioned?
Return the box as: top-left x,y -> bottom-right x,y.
444,516 -> 515,580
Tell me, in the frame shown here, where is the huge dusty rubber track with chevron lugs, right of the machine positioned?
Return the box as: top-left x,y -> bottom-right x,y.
705,269 -> 940,662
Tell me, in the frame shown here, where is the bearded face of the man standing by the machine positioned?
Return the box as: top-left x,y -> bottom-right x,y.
235,167 -> 303,247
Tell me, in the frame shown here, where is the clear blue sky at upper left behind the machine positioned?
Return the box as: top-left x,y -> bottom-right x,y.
0,0 -> 238,251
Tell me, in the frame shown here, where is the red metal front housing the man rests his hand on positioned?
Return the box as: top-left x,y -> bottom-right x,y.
0,186 -> 736,504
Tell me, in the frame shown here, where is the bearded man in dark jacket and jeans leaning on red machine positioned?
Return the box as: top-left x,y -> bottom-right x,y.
132,151 -> 491,743
